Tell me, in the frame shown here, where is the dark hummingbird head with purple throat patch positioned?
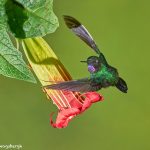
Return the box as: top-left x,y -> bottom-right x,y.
87,56 -> 101,73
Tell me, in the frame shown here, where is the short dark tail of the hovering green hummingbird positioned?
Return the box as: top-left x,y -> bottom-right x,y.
116,77 -> 128,93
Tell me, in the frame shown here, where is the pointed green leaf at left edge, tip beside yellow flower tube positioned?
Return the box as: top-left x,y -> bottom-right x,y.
0,26 -> 36,83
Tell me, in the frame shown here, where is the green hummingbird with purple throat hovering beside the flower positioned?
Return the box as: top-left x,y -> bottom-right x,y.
44,16 -> 128,93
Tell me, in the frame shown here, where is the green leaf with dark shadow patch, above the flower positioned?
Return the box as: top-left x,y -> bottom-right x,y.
0,0 -> 59,38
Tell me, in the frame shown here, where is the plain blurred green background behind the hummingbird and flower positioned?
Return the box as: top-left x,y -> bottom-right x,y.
0,0 -> 150,150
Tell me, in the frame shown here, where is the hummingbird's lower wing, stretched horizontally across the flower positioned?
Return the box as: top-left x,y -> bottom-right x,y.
44,78 -> 101,92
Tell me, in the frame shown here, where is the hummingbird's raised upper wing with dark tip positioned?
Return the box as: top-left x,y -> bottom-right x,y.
64,16 -> 100,54
